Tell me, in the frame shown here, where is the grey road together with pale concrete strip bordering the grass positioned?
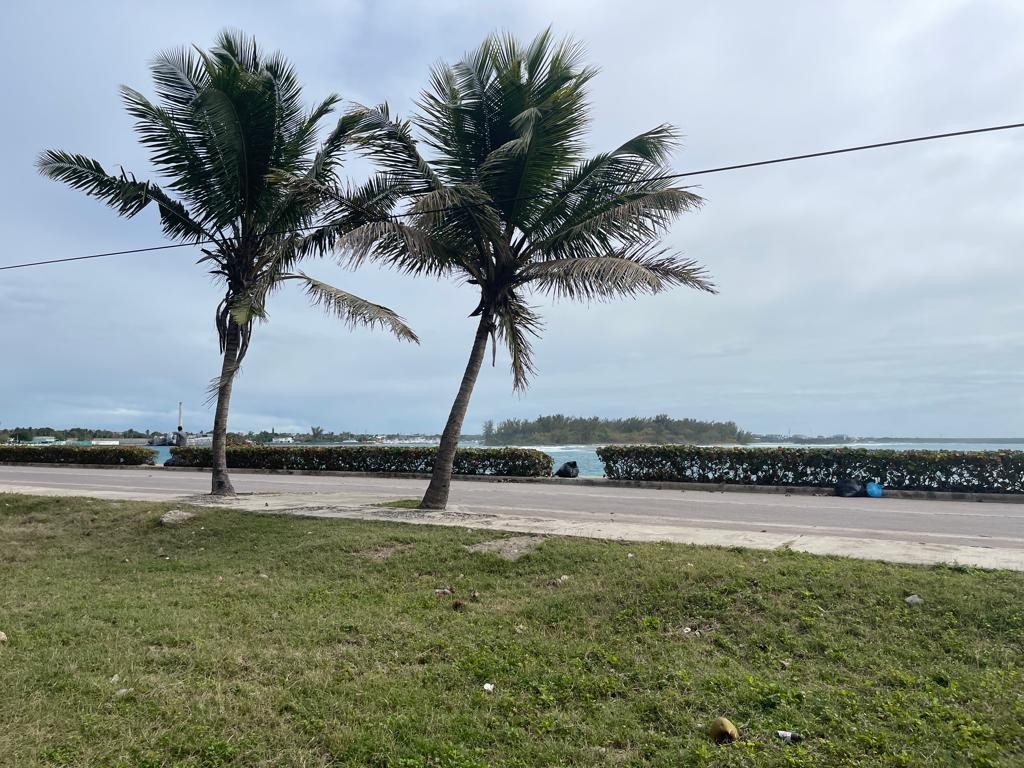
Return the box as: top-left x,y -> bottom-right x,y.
0,466 -> 1024,569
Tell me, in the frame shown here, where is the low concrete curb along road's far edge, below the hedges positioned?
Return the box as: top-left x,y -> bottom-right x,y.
0,462 -> 1024,504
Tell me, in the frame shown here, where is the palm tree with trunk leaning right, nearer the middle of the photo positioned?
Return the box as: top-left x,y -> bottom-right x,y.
336,31 -> 714,509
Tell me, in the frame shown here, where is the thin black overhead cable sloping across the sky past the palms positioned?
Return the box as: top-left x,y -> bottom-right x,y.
0,123 -> 1024,271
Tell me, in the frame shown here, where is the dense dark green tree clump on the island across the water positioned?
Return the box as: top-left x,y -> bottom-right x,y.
483,414 -> 753,445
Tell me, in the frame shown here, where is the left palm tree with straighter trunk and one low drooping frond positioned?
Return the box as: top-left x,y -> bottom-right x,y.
38,32 -> 417,495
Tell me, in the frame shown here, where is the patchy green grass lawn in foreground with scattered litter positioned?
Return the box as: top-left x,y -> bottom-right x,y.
0,494 -> 1024,768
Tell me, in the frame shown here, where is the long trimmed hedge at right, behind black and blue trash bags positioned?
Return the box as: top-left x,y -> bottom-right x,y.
597,445 -> 1024,494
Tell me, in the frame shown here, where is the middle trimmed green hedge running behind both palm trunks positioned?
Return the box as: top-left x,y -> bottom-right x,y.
166,445 -> 551,477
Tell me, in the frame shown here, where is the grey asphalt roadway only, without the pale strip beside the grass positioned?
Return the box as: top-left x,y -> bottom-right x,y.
0,466 -> 1024,555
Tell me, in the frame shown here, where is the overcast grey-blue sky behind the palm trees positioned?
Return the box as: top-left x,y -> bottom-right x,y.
0,0 -> 1024,436
